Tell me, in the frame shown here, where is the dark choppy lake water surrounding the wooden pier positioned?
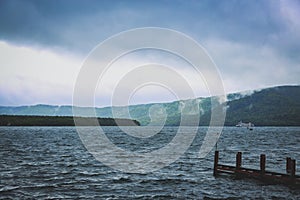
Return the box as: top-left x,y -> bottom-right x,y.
0,127 -> 300,199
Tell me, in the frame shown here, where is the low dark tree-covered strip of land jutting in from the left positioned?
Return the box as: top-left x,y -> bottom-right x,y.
0,115 -> 140,126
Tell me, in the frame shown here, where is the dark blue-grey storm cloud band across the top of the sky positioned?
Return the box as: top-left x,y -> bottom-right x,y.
0,0 -> 295,55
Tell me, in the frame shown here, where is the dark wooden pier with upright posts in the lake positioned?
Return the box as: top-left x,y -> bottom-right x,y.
214,151 -> 300,187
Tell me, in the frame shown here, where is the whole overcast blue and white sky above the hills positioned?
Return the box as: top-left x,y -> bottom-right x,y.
0,0 -> 300,107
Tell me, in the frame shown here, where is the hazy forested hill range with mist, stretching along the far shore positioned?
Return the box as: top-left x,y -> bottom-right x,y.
0,86 -> 300,126
